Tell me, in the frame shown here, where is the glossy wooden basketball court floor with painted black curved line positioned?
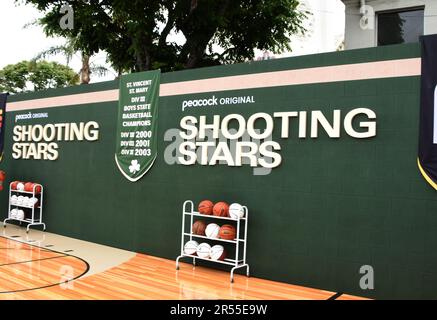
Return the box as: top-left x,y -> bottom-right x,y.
0,225 -> 361,300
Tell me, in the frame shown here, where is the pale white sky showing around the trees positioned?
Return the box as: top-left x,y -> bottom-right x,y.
0,0 -> 344,82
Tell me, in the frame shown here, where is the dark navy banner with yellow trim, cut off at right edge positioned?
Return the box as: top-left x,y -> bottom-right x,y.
418,35 -> 437,190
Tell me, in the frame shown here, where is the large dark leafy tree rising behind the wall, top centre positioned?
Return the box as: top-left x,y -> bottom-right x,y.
17,0 -> 305,73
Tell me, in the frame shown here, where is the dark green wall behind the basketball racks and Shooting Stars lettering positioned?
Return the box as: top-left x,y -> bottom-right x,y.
1,45 -> 437,298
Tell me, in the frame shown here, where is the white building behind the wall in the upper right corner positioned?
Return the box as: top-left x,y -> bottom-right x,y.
342,0 -> 437,49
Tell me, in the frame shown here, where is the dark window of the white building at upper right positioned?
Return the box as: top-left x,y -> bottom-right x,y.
378,9 -> 424,46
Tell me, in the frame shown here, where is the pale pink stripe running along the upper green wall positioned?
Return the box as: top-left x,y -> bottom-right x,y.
6,58 -> 421,112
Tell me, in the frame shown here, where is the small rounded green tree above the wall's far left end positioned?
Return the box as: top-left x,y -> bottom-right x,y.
0,61 -> 79,93
